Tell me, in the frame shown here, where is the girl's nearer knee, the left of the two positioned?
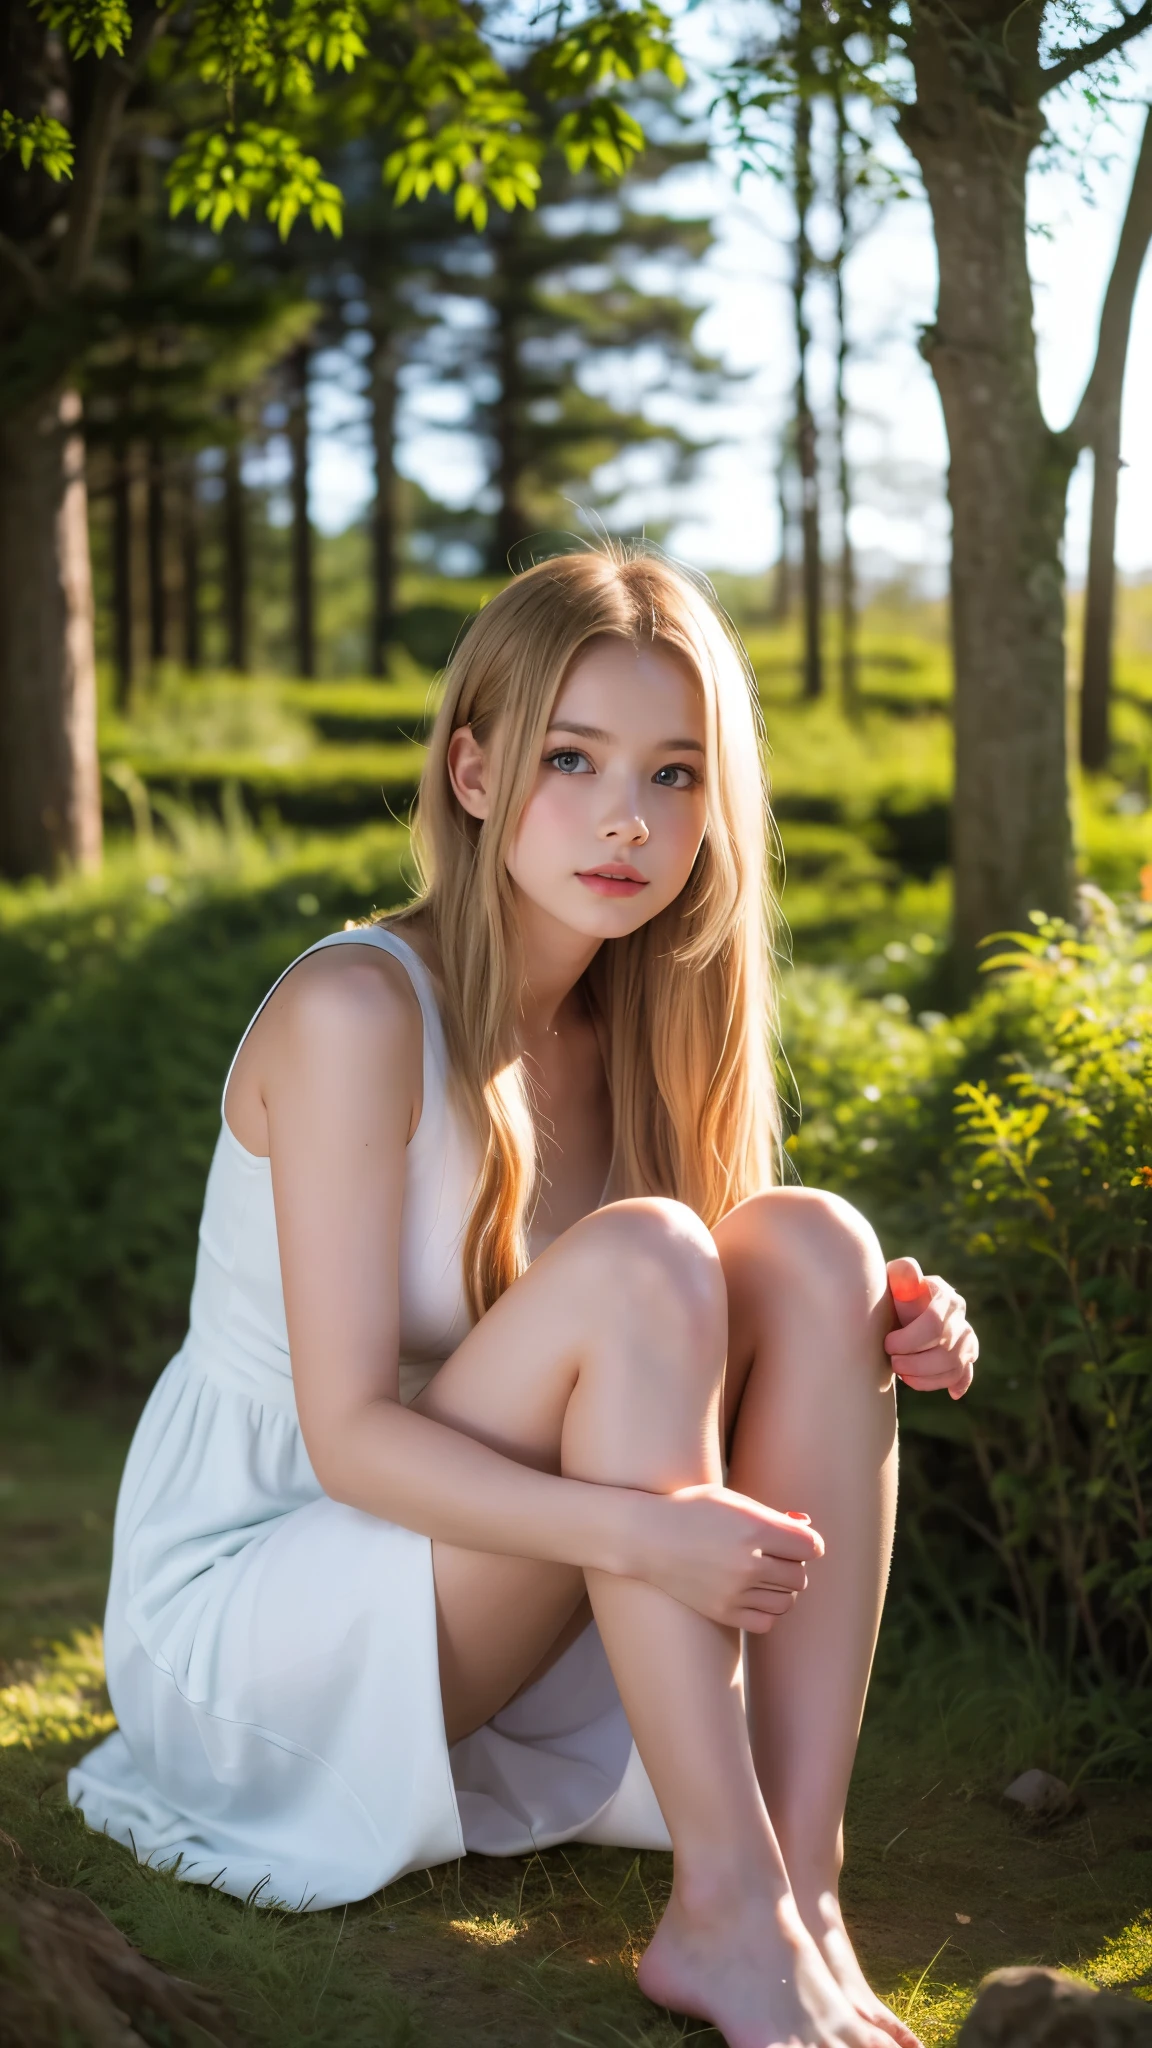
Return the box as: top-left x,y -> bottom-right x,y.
586,1196 -> 728,1356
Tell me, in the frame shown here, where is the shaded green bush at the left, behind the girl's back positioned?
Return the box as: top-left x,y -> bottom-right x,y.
0,821 -> 406,1384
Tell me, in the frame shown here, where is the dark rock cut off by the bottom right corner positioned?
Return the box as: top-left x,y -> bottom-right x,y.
955,1970 -> 1152,2048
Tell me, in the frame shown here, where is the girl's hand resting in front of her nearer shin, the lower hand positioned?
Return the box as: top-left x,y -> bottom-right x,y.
627,1487 -> 824,1636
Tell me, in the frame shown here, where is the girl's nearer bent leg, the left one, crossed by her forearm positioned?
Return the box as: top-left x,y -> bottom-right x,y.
418,1202 -> 883,2048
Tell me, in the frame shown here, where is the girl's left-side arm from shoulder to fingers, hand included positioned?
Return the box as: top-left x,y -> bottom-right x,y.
253,946 -> 822,1628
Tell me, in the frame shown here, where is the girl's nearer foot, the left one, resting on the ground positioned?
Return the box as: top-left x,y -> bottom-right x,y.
637,1886 -> 892,2048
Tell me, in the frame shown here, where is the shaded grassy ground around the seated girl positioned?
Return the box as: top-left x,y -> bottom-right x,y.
0,1393 -> 1152,2048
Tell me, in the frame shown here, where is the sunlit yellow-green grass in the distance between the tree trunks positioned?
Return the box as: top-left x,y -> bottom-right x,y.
91,586 -> 1152,963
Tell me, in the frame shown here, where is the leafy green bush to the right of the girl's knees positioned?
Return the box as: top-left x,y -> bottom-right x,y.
785,891 -> 1152,1683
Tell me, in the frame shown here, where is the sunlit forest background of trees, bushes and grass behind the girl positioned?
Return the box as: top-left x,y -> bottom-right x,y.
0,0 -> 1152,2044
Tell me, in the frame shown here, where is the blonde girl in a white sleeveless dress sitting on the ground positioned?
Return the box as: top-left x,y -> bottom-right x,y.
70,551 -> 976,2048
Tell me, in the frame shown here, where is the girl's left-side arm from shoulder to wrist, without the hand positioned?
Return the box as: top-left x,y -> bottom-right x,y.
258,948 -> 637,1571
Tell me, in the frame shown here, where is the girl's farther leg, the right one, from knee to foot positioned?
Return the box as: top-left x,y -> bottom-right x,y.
715,1190 -> 914,2044
